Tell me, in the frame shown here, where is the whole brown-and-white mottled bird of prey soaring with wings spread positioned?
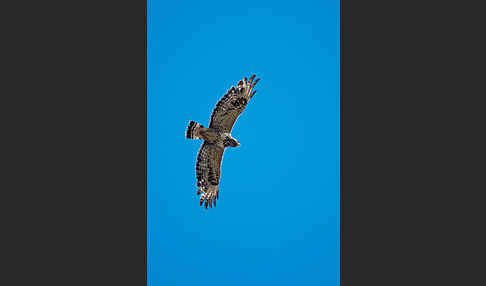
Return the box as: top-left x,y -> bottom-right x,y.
186,75 -> 260,209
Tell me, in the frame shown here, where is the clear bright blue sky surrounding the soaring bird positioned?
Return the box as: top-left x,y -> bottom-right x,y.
147,0 -> 339,286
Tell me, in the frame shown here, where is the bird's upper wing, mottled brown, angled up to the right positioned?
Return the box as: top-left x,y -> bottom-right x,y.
209,75 -> 260,132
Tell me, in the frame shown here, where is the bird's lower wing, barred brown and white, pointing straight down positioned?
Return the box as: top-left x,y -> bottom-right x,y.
196,141 -> 224,208
